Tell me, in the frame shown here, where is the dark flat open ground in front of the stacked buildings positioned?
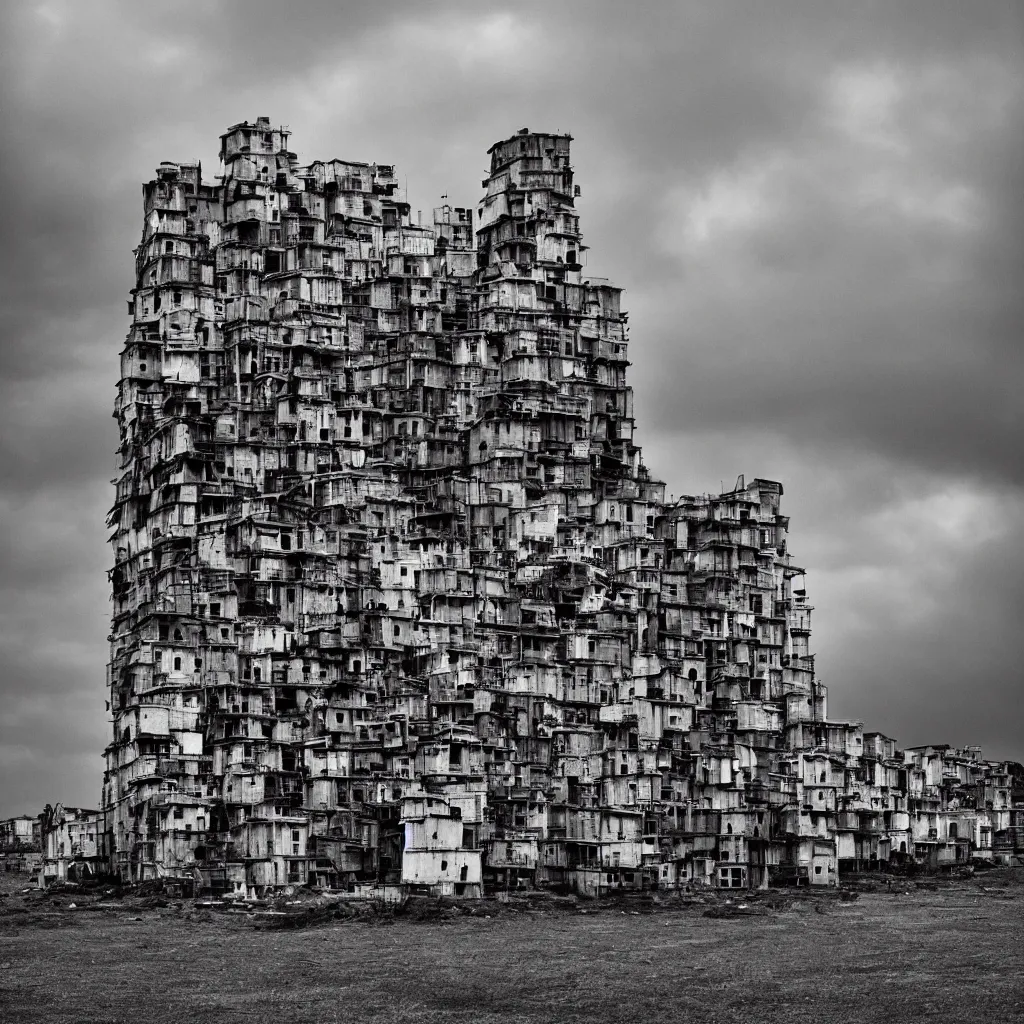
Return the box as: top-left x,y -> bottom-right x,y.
0,872 -> 1024,1024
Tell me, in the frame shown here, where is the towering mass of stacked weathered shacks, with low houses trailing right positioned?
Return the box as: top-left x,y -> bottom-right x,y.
102,118 -> 1024,895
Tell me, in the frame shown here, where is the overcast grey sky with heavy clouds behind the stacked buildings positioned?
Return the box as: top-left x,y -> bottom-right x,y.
0,0 -> 1024,816
